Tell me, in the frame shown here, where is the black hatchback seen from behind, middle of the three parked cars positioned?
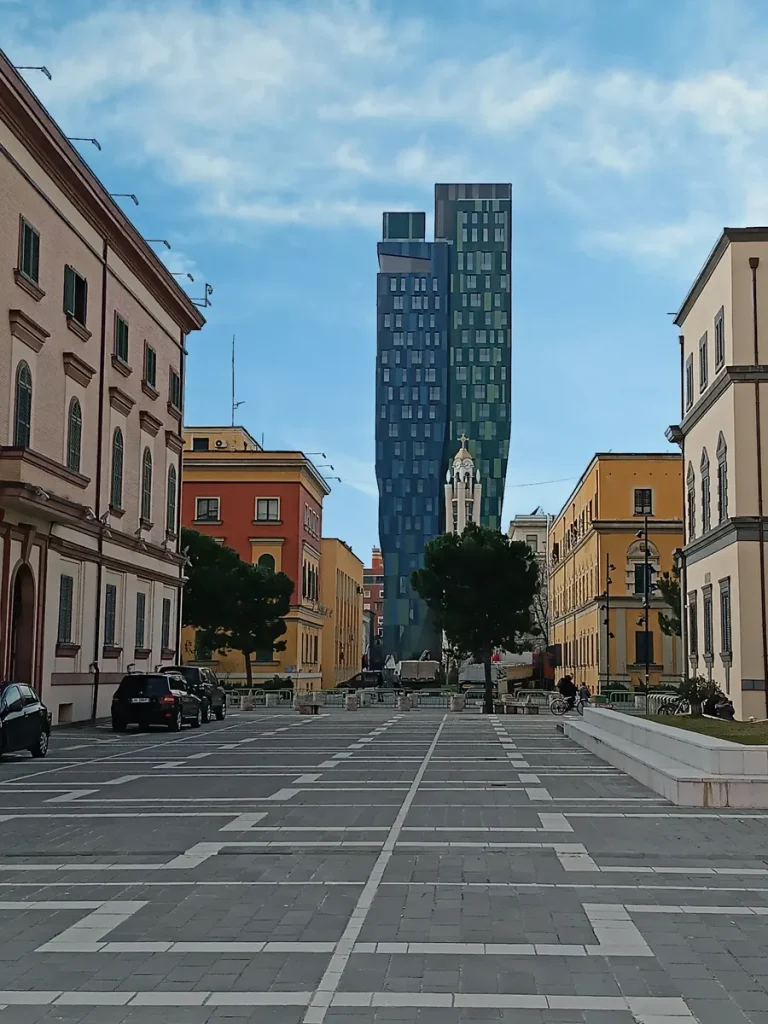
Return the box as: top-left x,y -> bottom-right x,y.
112,672 -> 203,732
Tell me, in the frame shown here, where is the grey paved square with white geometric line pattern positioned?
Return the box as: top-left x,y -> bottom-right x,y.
0,710 -> 768,1024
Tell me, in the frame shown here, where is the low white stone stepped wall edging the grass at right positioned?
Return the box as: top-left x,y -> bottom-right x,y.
563,708 -> 768,808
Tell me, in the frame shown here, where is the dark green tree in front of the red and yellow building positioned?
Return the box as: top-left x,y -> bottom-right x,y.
181,528 -> 293,686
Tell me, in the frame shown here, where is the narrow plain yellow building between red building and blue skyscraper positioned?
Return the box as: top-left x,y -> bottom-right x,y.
321,537 -> 365,689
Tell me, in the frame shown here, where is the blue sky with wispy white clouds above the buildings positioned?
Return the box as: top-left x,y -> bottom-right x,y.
6,0 -> 768,558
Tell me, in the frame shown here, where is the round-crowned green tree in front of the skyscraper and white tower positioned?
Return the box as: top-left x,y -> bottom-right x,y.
411,523 -> 539,714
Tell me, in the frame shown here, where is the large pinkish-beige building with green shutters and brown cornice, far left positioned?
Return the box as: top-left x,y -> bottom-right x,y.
0,51 -> 204,723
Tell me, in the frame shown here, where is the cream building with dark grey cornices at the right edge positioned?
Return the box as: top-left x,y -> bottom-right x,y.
667,227 -> 768,719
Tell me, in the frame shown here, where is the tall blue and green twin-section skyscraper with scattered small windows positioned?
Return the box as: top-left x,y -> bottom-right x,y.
376,184 -> 512,659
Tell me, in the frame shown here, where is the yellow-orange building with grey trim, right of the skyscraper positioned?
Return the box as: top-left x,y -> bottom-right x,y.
549,453 -> 683,691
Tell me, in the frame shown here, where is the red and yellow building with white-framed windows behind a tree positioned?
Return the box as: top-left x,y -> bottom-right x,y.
181,427 -> 331,689
